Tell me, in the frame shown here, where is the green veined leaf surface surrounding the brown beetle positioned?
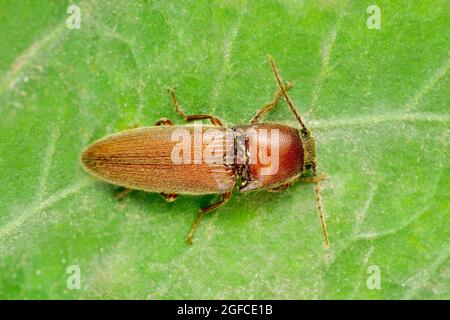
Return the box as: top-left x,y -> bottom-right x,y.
0,0 -> 450,299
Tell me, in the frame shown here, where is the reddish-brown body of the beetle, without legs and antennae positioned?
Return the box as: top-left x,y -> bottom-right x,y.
81,123 -> 311,195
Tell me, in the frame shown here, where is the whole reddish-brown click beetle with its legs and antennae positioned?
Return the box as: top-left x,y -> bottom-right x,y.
81,56 -> 329,247
